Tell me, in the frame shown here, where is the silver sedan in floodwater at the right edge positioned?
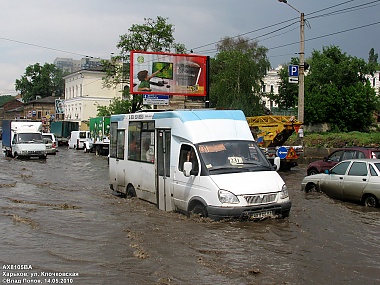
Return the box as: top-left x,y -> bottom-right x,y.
301,158 -> 380,207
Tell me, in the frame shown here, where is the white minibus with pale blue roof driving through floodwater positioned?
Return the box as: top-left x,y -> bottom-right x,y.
109,110 -> 291,220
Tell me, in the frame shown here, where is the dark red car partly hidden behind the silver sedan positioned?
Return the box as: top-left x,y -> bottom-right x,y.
307,147 -> 380,175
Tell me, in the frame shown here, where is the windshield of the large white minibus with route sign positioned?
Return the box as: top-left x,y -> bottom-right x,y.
197,141 -> 273,173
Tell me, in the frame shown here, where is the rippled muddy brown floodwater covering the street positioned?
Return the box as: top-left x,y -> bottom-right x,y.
0,147 -> 380,285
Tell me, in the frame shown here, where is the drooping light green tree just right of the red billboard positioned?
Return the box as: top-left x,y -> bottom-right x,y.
210,37 -> 270,116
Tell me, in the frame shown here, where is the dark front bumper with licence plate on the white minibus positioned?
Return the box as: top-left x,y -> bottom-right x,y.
207,201 -> 292,221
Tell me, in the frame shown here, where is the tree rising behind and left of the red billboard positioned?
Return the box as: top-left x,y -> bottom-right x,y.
103,16 -> 186,112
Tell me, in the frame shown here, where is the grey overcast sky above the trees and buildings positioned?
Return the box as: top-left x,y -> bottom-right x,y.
0,0 -> 380,95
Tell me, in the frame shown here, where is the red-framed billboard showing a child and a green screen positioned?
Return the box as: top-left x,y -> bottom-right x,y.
130,51 -> 207,96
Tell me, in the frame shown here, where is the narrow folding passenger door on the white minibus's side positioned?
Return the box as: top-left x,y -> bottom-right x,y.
156,129 -> 173,211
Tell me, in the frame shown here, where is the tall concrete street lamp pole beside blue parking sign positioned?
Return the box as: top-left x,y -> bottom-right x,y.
278,0 -> 305,123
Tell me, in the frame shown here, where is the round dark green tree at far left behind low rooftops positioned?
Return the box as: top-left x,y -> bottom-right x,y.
15,63 -> 65,102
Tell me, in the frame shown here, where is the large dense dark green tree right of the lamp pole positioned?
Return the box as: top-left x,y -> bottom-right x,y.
305,46 -> 379,131
